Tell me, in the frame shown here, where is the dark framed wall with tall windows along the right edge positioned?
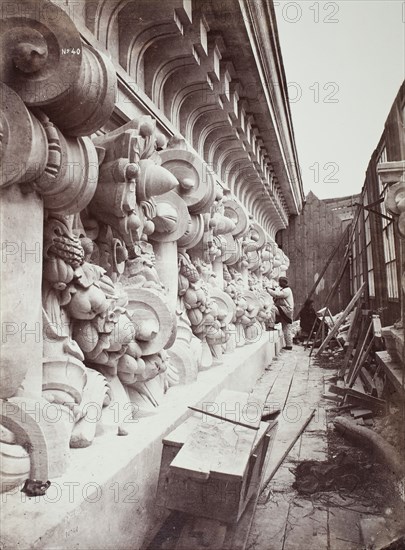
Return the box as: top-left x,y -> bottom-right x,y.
349,83 -> 405,325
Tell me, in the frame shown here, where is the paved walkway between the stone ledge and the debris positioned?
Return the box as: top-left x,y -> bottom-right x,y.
247,346 -> 404,550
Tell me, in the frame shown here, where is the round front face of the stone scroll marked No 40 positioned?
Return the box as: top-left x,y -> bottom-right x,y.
0,0 -> 82,106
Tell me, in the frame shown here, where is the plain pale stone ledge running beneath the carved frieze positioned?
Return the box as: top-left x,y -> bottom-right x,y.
0,331 -> 282,550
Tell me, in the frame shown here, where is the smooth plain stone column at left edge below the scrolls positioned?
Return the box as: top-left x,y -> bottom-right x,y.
0,185 -> 43,398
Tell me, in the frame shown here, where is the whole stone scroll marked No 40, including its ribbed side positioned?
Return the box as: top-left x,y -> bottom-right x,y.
0,0 -> 117,137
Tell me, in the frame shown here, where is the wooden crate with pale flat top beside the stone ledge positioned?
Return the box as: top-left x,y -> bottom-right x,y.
157,392 -> 277,523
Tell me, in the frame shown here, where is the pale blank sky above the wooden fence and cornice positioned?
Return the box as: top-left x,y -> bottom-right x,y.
274,0 -> 405,202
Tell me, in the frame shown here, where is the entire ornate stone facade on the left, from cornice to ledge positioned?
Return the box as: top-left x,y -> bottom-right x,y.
0,0 -> 303,548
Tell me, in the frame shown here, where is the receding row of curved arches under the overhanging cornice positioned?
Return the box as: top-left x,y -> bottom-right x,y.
81,0 -> 289,235
